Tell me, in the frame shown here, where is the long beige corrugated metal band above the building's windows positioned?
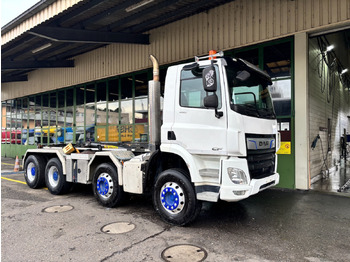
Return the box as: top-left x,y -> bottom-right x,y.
2,0 -> 350,100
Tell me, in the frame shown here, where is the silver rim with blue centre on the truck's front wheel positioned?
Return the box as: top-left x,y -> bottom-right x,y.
160,182 -> 185,214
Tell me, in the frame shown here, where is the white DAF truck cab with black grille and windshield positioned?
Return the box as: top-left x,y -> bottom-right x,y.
160,53 -> 279,205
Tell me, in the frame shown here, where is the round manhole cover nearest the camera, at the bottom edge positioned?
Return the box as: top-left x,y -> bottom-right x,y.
162,245 -> 208,262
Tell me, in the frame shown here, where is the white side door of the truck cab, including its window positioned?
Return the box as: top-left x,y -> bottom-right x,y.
172,65 -> 227,155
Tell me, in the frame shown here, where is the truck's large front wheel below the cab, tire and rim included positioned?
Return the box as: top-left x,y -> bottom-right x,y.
153,169 -> 202,226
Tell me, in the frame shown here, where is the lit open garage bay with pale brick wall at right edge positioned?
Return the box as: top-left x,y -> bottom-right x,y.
309,29 -> 350,192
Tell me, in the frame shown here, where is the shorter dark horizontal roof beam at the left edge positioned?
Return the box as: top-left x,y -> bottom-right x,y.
1,60 -> 74,71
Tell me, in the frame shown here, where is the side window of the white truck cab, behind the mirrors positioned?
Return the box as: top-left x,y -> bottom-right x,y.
180,67 -> 221,108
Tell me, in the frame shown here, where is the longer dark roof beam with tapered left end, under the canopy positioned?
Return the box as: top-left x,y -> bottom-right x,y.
28,26 -> 149,45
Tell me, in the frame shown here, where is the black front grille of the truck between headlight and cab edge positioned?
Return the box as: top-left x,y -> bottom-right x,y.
247,136 -> 276,179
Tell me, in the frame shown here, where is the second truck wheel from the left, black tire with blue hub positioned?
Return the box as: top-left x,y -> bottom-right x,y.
45,158 -> 72,195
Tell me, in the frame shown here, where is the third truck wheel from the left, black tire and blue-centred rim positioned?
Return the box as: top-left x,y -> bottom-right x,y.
92,163 -> 125,207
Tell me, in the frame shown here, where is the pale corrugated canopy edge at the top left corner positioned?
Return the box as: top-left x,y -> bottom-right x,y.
1,0 -> 83,45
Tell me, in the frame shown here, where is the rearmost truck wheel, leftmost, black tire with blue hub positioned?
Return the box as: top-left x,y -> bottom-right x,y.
24,155 -> 45,189
